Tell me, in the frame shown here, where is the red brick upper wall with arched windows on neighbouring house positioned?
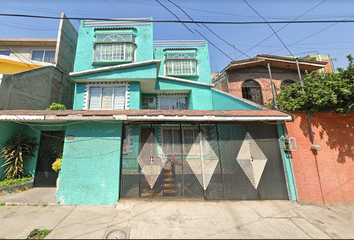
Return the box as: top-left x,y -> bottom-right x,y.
227,66 -> 305,104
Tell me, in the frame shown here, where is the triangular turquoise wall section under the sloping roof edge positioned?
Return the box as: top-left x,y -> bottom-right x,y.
212,90 -> 261,110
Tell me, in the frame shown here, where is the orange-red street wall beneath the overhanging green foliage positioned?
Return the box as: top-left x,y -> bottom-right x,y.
286,113 -> 354,204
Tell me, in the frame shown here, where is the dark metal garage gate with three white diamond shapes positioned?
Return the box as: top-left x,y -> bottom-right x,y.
120,122 -> 288,200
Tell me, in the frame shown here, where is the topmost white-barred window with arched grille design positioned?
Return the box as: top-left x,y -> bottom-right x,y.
93,33 -> 136,63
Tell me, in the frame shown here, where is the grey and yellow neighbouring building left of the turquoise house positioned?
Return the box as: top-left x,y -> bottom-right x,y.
0,14 -> 77,110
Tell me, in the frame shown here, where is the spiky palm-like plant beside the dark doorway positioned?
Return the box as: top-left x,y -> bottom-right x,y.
0,132 -> 38,179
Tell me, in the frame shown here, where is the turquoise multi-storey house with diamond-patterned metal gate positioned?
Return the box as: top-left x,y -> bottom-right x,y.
0,18 -> 297,205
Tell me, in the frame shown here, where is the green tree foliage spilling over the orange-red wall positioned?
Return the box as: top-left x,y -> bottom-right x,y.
278,55 -> 354,115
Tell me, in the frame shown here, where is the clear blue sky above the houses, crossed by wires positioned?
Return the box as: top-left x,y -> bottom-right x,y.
0,0 -> 354,72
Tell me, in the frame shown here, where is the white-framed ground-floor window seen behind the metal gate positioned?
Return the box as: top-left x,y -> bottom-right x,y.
162,128 -> 205,155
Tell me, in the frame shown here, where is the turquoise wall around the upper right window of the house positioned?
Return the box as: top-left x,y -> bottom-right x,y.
154,44 -> 211,84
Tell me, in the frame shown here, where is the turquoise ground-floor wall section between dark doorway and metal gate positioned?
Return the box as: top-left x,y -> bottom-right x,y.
57,121 -> 122,206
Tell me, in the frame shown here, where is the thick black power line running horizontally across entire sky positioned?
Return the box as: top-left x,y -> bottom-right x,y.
0,13 -> 354,25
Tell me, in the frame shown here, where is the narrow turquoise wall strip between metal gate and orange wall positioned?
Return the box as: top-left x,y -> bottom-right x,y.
277,122 -> 299,201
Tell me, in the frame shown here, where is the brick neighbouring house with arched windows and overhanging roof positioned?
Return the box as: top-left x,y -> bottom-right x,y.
212,54 -> 332,105
